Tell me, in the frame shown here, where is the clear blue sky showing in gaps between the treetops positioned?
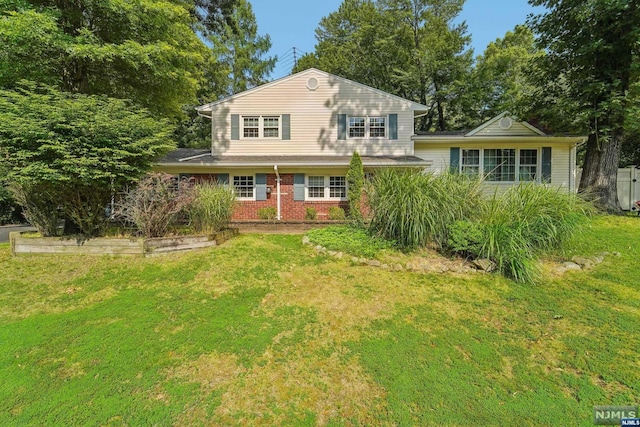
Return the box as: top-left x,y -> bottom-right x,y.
250,0 -> 541,79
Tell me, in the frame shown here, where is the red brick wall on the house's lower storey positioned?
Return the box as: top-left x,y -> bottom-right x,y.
193,174 -> 349,221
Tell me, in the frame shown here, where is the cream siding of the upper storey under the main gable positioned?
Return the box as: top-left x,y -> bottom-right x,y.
212,73 -> 414,156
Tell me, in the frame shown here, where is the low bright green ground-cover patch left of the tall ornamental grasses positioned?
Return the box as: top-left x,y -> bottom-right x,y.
307,225 -> 395,258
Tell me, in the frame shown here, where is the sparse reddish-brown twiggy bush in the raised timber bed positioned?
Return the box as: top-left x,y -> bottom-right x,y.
116,173 -> 194,241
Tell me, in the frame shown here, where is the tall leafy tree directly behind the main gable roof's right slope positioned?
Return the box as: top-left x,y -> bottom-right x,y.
303,0 -> 472,130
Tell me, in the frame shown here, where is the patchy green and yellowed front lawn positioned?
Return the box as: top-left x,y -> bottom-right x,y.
0,217 -> 640,426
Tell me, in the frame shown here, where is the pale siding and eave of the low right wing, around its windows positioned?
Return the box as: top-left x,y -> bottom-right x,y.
415,141 -> 575,192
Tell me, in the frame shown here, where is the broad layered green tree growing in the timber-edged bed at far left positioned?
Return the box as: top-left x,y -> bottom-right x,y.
0,82 -> 173,236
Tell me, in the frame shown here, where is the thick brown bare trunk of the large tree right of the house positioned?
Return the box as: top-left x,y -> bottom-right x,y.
579,133 -> 622,213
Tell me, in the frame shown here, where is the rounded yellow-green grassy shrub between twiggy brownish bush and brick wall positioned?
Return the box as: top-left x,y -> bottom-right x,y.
187,182 -> 236,234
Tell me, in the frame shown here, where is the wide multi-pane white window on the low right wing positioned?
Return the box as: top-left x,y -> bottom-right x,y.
460,148 -> 540,182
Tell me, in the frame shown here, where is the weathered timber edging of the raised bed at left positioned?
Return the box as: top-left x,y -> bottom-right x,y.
10,228 -> 238,257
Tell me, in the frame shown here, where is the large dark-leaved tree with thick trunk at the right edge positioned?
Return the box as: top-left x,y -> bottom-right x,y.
529,0 -> 640,211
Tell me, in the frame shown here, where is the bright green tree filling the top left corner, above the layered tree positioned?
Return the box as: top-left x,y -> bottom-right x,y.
0,0 -> 207,117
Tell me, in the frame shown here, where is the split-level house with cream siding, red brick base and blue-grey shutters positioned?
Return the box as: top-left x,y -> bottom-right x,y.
156,68 -> 582,221
